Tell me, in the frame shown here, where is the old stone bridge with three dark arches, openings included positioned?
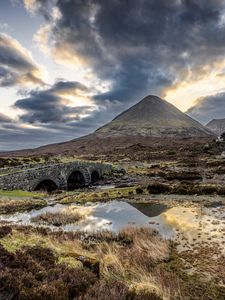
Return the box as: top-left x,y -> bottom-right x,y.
0,161 -> 112,191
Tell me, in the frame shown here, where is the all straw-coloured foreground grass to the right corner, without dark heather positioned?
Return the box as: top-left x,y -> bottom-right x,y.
0,227 -> 225,300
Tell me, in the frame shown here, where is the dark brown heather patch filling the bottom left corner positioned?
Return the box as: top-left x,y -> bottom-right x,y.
0,245 -> 97,300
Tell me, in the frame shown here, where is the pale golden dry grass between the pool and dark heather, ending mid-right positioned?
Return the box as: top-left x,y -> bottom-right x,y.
1,228 -> 170,299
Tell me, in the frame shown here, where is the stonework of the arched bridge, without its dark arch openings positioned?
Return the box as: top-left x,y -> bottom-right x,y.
0,161 -> 112,191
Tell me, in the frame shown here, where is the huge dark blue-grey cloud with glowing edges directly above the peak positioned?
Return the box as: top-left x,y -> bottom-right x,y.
31,0 -> 225,103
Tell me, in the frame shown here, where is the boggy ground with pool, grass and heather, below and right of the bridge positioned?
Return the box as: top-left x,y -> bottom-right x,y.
0,139 -> 225,300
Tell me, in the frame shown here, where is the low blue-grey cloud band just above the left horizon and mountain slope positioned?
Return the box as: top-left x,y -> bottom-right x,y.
0,97 -> 125,151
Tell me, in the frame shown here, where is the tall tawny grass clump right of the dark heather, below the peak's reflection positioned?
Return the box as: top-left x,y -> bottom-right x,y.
96,228 -> 170,299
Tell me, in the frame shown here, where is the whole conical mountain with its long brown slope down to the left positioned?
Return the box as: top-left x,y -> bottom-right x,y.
1,95 -> 214,156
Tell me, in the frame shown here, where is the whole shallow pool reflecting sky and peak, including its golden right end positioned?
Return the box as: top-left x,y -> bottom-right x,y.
0,201 -> 225,253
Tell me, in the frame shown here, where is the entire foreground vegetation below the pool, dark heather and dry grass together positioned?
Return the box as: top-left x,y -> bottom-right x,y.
0,226 -> 225,300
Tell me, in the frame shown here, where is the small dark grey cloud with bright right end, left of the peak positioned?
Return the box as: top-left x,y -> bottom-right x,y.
14,81 -> 94,124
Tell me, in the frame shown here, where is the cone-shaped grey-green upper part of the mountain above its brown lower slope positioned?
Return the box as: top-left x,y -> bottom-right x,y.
96,95 -> 212,137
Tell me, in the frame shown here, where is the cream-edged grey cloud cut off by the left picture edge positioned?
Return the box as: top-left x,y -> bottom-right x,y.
0,33 -> 43,87
